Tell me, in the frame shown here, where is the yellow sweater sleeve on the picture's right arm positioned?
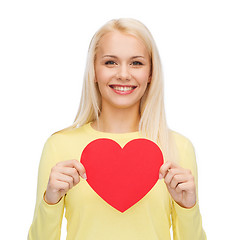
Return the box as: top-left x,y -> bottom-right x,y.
172,139 -> 207,240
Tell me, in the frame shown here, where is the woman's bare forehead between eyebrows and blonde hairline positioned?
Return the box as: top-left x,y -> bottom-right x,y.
97,31 -> 148,57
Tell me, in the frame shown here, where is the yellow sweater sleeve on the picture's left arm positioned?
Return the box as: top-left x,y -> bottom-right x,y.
28,136 -> 65,240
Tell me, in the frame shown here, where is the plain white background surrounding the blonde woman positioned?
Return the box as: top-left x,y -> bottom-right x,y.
0,0 -> 240,240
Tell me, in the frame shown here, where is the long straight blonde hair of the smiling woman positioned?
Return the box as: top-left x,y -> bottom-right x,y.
51,18 -> 176,161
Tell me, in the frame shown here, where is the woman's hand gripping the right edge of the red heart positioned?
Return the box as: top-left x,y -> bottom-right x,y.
159,162 -> 196,208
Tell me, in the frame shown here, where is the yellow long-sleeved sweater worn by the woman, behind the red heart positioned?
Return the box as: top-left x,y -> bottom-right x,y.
28,123 -> 206,240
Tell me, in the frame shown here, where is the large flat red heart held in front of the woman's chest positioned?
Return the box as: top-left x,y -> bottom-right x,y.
80,138 -> 163,212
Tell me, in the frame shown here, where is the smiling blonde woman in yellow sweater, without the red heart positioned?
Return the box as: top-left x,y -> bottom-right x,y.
28,19 -> 206,240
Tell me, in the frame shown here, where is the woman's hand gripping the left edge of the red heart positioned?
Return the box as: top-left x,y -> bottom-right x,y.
44,159 -> 87,204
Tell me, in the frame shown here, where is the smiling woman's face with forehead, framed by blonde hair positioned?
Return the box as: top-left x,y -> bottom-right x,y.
95,31 -> 151,108
